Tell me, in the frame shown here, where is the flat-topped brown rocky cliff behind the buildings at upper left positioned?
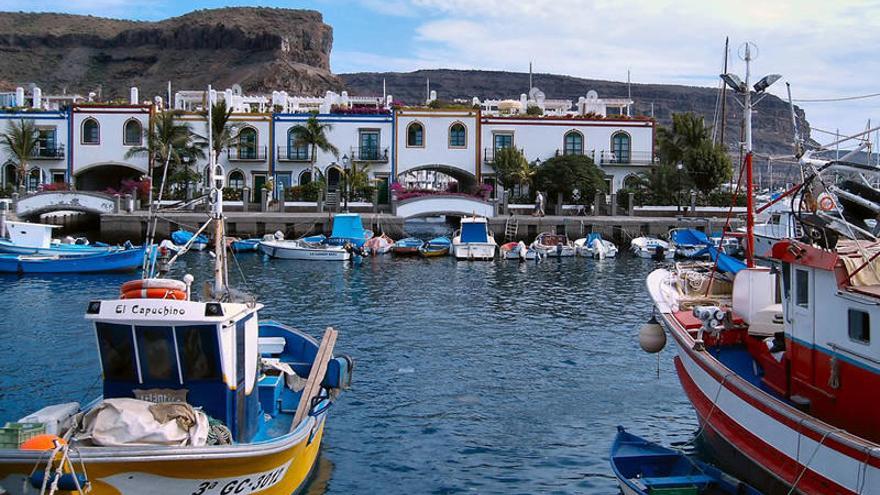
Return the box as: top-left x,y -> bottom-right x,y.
0,8 -> 342,99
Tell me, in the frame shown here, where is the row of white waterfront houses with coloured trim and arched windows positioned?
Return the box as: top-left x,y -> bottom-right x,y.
0,88 -> 655,202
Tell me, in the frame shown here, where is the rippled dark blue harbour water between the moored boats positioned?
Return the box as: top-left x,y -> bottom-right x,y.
0,239 -> 697,494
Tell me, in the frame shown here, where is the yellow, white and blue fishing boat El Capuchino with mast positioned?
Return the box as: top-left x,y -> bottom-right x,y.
0,91 -> 352,495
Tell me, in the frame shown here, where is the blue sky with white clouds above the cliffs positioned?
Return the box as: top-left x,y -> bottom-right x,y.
0,0 -> 880,146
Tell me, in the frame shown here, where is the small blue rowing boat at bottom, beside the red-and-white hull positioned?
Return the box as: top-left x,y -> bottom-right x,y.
611,426 -> 761,495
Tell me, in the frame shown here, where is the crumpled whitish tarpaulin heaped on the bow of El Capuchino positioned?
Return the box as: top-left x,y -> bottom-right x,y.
77,399 -> 208,447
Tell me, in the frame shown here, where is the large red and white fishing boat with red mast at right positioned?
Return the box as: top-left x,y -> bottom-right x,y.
640,43 -> 880,494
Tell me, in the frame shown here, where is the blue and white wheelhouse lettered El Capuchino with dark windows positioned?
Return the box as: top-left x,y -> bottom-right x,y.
86,299 -> 262,442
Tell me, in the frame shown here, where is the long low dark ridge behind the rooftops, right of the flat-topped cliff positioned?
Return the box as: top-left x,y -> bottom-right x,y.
339,69 -> 810,154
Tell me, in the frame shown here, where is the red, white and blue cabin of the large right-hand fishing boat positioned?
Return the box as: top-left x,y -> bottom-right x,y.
733,240 -> 880,442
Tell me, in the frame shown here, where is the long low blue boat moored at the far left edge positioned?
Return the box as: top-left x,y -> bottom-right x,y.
0,246 -> 146,274
